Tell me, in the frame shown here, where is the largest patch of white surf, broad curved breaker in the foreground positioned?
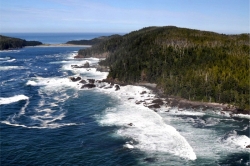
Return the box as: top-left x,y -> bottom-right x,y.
99,102 -> 196,160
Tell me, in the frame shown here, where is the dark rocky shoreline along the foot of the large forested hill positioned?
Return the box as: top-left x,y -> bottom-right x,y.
70,62 -> 250,117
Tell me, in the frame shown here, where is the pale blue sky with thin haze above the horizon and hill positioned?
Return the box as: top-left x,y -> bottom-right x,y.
0,0 -> 250,34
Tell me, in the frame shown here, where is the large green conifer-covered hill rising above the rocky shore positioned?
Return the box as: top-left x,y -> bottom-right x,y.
77,26 -> 250,111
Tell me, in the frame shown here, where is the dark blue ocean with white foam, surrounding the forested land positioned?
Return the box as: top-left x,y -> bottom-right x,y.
0,34 -> 250,166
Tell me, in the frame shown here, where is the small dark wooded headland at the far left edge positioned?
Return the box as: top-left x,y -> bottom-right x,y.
0,35 -> 42,50
